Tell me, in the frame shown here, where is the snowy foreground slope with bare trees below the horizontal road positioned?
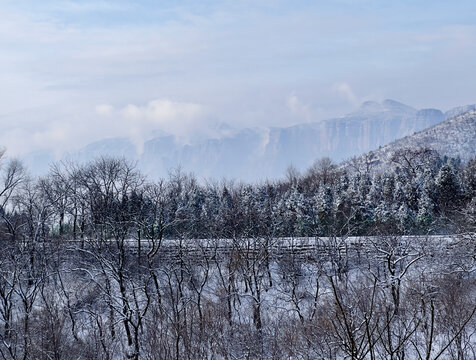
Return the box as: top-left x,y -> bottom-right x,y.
0,235 -> 476,359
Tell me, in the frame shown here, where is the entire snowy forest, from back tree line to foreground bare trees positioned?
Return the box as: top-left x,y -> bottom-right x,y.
0,148 -> 476,360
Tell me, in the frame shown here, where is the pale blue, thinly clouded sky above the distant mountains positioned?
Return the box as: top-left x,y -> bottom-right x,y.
0,0 -> 476,156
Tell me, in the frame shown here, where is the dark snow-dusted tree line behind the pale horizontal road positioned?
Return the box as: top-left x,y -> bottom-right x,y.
0,149 -> 476,240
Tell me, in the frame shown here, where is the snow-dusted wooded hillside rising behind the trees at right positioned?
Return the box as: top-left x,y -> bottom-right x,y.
343,107 -> 476,172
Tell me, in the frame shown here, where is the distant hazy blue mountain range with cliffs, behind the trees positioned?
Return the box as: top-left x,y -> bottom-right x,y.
24,100 -> 476,181
